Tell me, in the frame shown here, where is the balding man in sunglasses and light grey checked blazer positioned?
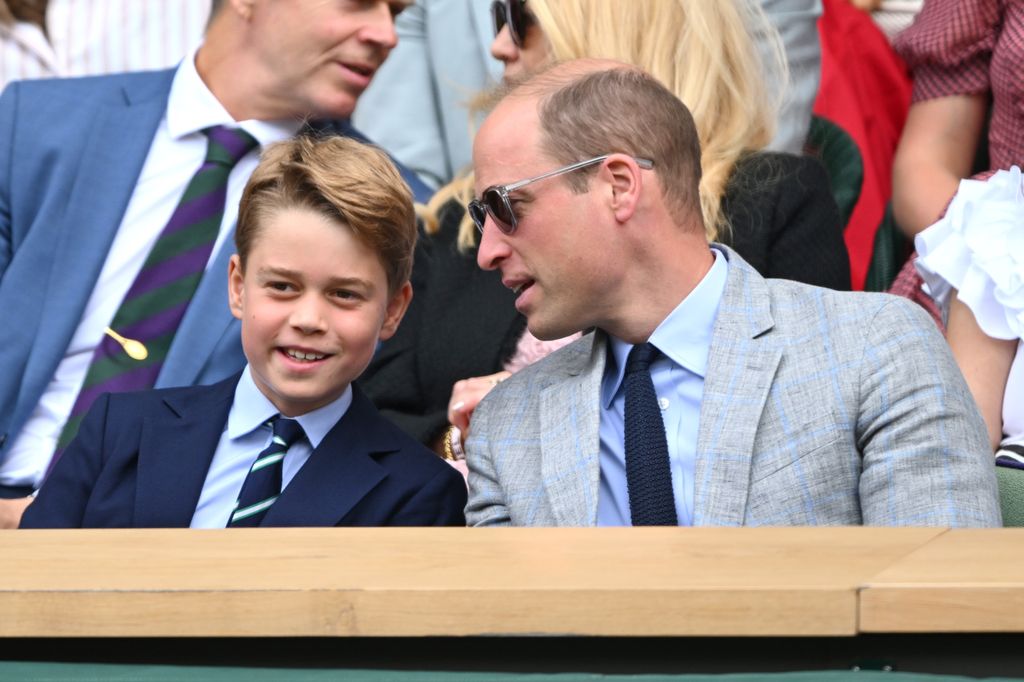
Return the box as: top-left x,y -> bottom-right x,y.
466,60 -> 1000,526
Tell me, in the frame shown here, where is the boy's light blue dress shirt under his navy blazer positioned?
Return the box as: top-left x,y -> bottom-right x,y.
191,365 -> 352,528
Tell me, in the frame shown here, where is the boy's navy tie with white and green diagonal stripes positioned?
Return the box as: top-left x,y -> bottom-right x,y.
233,417 -> 304,528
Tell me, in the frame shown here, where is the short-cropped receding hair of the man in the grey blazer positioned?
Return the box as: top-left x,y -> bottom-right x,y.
528,62 -> 703,225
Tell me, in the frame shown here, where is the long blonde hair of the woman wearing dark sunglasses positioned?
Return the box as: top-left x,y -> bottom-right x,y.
424,0 -> 787,248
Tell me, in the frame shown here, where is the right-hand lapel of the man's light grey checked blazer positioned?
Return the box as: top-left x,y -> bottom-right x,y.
693,247 -> 782,525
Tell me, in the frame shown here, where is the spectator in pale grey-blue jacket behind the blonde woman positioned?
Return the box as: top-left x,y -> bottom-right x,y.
354,0 -> 821,187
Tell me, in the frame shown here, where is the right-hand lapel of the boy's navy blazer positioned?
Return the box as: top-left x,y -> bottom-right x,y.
262,386 -> 389,526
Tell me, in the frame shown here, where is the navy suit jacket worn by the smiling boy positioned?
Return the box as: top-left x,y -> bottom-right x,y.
22,375 -> 466,528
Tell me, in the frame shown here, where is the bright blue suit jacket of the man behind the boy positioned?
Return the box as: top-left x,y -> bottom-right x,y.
0,70 -> 430,459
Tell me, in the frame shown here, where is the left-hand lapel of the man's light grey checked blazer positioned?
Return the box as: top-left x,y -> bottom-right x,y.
539,333 -> 605,526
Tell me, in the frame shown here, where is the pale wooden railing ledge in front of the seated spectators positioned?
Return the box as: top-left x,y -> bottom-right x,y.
0,527 -> 1024,637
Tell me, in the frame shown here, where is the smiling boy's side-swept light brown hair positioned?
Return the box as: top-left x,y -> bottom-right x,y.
234,136 -> 416,294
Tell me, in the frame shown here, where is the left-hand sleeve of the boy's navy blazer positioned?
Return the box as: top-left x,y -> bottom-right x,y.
20,393 -> 111,528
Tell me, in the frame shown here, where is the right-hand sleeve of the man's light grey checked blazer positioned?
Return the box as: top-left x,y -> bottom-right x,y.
856,297 -> 1001,527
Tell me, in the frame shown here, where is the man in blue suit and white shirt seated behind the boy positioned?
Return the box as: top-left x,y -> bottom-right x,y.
0,0 -> 429,526
